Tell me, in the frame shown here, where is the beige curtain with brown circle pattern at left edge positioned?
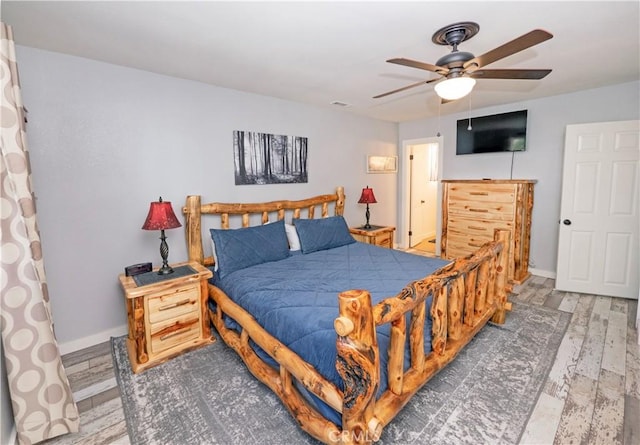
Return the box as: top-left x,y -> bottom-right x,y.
0,23 -> 80,444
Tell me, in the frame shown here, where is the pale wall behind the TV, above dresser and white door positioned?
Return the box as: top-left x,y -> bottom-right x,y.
399,81 -> 640,276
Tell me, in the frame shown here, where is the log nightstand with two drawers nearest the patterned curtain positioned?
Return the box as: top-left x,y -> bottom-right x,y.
119,262 -> 215,373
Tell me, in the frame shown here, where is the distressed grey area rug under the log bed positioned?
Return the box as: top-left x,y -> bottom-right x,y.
112,303 -> 571,445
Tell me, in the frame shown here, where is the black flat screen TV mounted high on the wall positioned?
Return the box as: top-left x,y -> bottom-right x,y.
456,110 -> 527,155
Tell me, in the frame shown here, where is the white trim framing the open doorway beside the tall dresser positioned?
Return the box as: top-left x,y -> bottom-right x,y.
396,136 -> 444,251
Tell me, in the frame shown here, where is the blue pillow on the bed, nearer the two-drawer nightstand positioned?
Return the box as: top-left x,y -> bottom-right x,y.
209,220 -> 289,278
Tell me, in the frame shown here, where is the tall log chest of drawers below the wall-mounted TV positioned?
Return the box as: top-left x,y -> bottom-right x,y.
441,179 -> 537,283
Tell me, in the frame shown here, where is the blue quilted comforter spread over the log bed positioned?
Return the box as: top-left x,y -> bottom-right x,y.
214,242 -> 447,425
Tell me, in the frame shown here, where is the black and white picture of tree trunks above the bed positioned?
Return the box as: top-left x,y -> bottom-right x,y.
233,131 -> 307,185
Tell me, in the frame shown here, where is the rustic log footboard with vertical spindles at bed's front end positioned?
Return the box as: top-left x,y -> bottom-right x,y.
335,230 -> 511,443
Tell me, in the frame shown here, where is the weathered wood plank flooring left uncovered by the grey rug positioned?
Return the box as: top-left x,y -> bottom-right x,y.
45,276 -> 640,445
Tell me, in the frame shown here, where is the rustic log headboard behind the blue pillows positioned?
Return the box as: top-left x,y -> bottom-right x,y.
182,186 -> 345,266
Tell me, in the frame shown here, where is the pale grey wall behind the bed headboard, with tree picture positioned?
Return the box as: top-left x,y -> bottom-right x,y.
12,46 -> 398,353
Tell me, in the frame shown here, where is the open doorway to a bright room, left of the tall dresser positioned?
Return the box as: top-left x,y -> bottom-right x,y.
401,138 -> 441,256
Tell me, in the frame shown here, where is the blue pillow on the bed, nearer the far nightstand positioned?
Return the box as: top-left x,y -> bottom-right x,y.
293,216 -> 356,253
